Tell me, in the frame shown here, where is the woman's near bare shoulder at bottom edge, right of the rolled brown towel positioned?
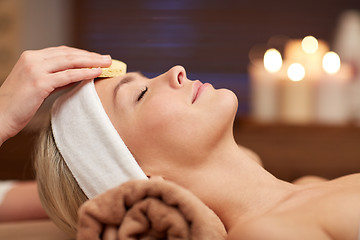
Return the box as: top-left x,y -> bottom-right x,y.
226,216 -> 330,240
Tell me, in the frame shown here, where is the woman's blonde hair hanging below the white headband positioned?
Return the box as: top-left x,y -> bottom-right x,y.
34,121 -> 88,237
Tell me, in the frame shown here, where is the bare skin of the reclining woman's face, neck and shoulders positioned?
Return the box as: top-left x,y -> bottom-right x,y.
95,66 -> 360,240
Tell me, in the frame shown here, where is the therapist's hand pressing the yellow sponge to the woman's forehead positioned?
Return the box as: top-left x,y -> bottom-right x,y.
0,46 -> 111,145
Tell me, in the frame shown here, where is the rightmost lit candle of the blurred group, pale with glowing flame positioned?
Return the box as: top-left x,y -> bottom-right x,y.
316,52 -> 352,124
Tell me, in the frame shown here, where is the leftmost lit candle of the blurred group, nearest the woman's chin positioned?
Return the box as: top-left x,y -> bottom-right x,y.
249,49 -> 282,122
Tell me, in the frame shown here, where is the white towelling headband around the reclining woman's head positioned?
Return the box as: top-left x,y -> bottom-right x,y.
51,80 -> 147,198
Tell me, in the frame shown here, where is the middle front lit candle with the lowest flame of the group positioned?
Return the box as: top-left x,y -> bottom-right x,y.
281,63 -> 313,124
